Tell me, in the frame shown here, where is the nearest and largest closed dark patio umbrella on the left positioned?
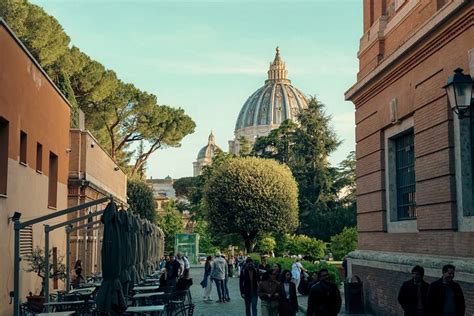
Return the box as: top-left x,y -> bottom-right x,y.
95,202 -> 127,314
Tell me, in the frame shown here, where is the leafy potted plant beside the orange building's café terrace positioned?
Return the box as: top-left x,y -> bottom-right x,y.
24,247 -> 66,309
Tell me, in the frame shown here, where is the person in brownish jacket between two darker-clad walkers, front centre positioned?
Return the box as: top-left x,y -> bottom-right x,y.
257,270 -> 280,316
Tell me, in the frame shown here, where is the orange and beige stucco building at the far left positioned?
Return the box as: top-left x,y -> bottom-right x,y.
0,19 -> 70,316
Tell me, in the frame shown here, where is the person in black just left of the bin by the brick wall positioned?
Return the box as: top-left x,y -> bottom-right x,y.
306,269 -> 342,316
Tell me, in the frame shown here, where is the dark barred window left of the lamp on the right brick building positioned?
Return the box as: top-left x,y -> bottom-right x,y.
394,132 -> 416,220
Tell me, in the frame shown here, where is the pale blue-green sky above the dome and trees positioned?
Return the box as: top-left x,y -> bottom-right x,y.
32,0 -> 362,178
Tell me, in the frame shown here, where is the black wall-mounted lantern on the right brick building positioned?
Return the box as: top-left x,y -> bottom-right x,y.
444,68 -> 474,119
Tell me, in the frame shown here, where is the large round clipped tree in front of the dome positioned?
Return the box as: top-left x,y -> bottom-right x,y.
204,157 -> 298,252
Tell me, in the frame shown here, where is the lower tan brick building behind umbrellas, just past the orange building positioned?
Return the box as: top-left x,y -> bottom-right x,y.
68,127 -> 127,276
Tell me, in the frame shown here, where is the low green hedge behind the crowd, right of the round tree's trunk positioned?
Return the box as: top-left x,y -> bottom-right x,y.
244,253 -> 341,284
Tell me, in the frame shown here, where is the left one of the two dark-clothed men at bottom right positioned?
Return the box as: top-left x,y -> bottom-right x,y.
398,265 -> 429,316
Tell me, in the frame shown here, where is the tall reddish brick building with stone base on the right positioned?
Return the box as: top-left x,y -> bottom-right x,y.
346,0 -> 474,315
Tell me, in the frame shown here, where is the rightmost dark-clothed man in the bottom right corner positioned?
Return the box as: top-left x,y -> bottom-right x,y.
427,264 -> 466,316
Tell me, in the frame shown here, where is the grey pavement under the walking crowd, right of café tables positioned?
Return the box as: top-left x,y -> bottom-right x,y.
190,267 -> 304,316
